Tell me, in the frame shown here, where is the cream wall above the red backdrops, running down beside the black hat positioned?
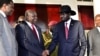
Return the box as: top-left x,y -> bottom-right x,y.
14,0 -> 93,20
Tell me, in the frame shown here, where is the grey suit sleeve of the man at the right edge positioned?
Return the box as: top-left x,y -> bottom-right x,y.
87,32 -> 93,56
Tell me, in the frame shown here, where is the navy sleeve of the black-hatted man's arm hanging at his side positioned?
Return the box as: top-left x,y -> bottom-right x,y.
79,23 -> 87,56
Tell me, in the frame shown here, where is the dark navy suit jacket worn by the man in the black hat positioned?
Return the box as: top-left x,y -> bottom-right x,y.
48,20 -> 86,56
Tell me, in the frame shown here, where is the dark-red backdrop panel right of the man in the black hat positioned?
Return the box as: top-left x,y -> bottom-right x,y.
78,6 -> 94,29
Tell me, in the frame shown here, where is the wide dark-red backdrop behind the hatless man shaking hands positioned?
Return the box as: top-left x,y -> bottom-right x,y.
8,3 -> 60,24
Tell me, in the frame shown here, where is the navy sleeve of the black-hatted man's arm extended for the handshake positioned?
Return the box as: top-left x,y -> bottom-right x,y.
48,27 -> 58,53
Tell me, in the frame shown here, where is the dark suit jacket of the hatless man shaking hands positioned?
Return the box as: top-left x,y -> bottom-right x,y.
16,22 -> 44,56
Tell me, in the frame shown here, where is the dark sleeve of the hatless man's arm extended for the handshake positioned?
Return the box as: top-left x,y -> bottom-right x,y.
16,25 -> 43,56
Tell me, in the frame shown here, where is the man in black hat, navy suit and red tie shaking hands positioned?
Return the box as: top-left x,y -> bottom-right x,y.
46,5 -> 87,56
